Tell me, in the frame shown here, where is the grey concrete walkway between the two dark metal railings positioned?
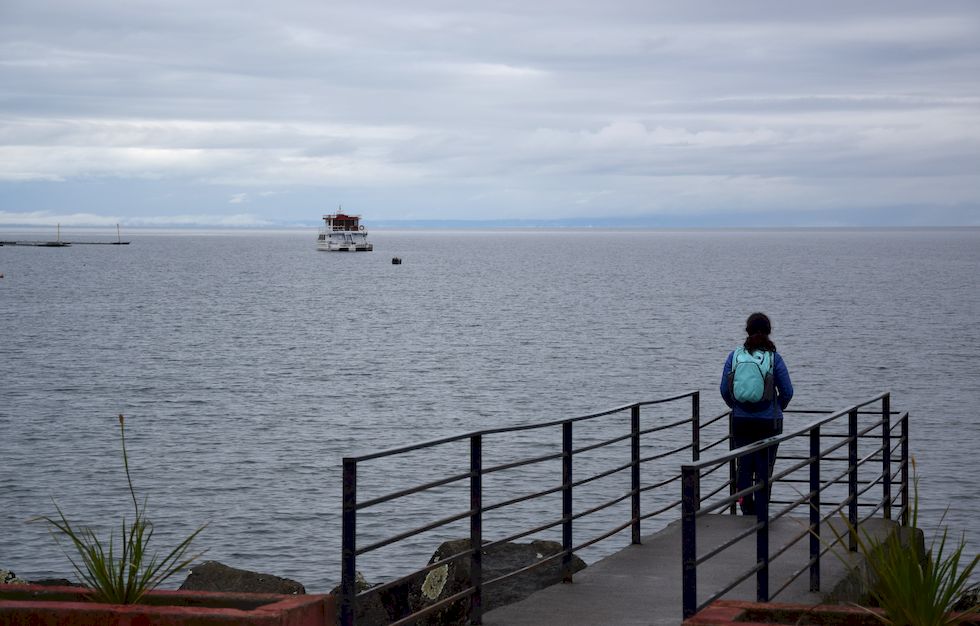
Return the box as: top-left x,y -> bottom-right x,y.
483,515 -> 895,626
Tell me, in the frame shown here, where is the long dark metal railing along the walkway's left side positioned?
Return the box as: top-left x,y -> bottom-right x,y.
340,391 -> 731,625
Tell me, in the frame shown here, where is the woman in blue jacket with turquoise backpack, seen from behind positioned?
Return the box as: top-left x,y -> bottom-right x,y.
721,313 -> 793,515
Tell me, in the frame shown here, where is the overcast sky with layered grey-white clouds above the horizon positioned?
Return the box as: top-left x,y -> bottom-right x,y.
0,0 -> 980,226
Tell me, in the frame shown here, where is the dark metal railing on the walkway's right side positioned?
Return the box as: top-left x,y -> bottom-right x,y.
681,393 -> 909,618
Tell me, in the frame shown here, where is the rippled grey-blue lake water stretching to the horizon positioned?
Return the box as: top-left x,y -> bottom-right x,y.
0,229 -> 980,591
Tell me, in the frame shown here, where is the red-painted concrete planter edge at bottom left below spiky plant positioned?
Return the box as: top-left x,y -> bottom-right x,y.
0,585 -> 336,626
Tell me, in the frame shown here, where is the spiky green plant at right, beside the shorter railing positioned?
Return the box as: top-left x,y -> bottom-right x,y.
831,459 -> 980,626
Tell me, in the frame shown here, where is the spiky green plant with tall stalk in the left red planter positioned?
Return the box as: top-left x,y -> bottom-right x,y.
38,415 -> 207,604
